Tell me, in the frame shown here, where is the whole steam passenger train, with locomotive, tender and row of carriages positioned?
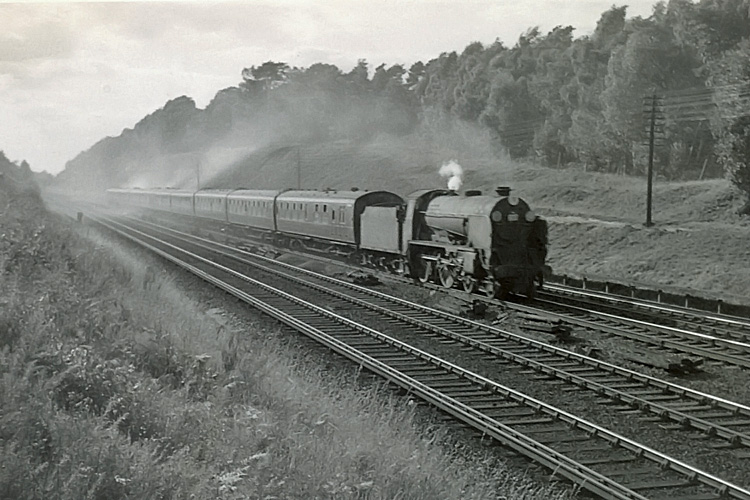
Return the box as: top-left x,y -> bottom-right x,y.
107,186 -> 550,298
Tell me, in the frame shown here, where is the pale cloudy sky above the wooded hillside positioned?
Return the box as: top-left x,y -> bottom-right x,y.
0,0 -> 656,174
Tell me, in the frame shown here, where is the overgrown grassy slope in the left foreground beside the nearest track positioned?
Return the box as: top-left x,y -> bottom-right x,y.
0,191 -> 570,500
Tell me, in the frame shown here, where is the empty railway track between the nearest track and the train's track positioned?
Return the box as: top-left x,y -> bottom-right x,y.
119,215 -> 750,447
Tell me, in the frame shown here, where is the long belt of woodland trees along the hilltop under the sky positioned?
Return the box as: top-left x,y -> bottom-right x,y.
55,0 -> 750,209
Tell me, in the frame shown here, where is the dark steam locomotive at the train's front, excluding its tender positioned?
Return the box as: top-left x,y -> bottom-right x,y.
409,187 -> 548,297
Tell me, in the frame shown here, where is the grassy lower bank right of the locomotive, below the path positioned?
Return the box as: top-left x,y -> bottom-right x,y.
536,183 -> 750,305
